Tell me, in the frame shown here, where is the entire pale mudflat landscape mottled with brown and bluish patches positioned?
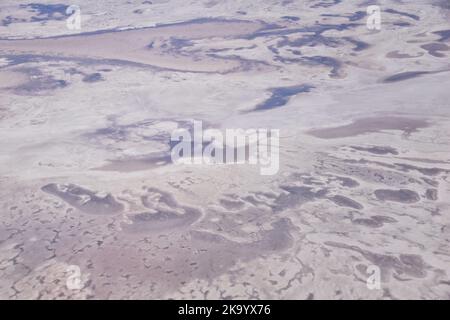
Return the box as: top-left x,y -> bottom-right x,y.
0,0 -> 450,299
